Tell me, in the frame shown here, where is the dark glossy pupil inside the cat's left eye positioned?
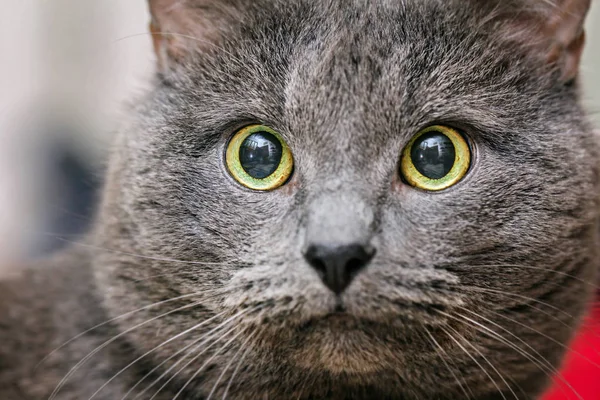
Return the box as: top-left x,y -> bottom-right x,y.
240,132 -> 283,179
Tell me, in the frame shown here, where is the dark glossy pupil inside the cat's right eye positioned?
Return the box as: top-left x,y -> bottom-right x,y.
410,132 -> 456,179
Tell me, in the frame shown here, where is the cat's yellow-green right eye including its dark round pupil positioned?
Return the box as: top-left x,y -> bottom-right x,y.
400,125 -> 471,191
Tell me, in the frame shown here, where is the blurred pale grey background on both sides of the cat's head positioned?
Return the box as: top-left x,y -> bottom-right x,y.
0,0 -> 600,273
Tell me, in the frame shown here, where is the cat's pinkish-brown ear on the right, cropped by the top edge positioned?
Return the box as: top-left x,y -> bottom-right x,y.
508,0 -> 591,82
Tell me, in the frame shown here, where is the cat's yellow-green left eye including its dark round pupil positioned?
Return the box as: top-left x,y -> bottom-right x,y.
225,125 -> 294,190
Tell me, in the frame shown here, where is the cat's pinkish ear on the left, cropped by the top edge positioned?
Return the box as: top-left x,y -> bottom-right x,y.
148,0 -> 243,71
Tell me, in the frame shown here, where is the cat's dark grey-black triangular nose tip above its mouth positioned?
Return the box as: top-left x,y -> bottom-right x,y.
304,244 -> 375,294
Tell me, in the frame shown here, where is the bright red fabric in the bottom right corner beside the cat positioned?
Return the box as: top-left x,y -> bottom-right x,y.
542,305 -> 600,400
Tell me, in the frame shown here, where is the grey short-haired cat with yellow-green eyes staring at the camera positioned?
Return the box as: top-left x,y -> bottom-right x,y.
0,0 -> 600,400
